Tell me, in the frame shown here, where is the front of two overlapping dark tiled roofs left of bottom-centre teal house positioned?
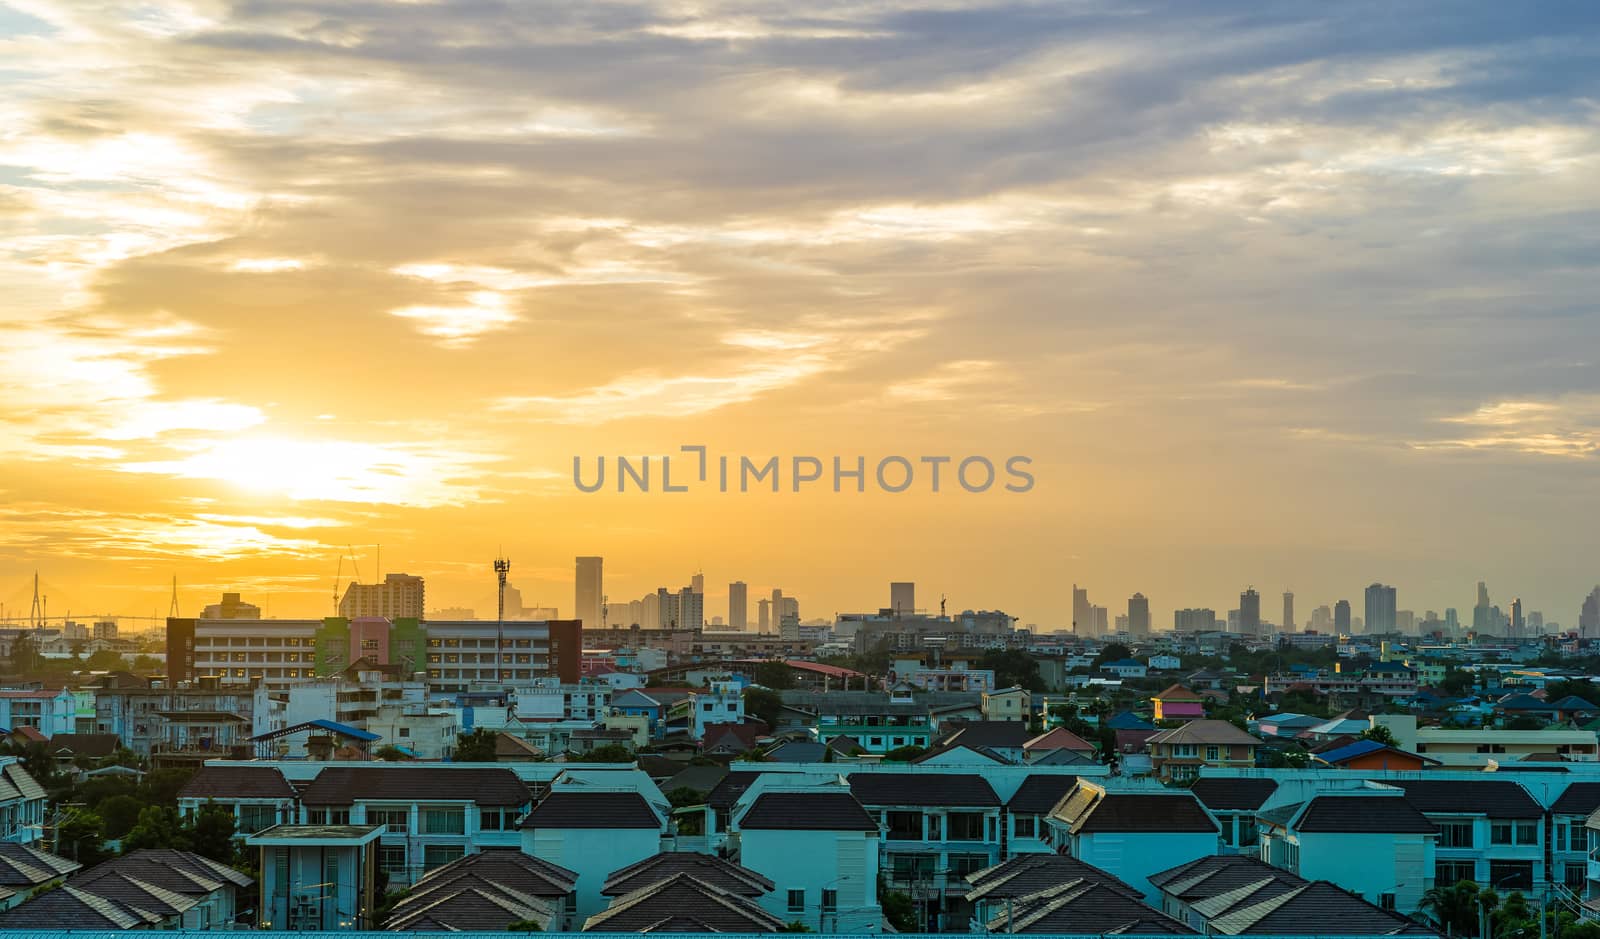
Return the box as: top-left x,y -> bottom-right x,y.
584,873 -> 786,933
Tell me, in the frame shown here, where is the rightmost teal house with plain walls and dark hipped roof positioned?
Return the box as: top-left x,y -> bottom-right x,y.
1258,785 -> 1453,912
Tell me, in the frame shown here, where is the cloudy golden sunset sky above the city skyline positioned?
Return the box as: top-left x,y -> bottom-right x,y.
0,0 -> 1600,629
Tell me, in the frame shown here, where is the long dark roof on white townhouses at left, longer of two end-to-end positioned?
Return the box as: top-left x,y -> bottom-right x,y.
301,766 -> 533,806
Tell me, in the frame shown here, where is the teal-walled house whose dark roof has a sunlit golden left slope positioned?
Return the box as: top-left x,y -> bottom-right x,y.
1046,779 -> 1221,902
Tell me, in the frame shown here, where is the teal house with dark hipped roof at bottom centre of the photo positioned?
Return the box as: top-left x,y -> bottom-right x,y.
731,785 -> 883,933
